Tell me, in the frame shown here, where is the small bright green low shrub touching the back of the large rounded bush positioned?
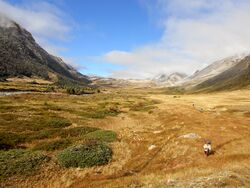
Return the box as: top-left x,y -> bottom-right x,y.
84,130 -> 117,142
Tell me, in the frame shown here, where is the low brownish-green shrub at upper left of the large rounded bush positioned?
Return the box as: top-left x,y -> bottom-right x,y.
33,139 -> 72,151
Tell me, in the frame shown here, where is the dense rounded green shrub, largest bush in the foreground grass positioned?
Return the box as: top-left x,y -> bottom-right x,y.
57,141 -> 112,168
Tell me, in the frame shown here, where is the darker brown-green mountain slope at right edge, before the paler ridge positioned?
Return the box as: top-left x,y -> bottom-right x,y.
195,55 -> 250,91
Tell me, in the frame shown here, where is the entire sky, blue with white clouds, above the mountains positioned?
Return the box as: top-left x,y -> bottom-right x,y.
0,0 -> 250,79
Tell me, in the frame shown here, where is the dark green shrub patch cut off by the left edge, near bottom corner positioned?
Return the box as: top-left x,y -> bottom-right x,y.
0,149 -> 49,179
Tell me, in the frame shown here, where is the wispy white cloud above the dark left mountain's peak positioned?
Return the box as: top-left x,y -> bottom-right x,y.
0,0 -> 73,53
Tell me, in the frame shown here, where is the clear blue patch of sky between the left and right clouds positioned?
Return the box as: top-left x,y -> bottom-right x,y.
1,0 -> 163,76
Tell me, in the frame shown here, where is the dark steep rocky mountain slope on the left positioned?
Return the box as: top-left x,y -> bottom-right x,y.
0,15 -> 90,83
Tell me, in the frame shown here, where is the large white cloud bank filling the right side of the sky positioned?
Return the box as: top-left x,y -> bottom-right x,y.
102,0 -> 250,78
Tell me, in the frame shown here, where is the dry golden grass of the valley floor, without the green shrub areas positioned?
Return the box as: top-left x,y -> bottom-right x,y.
0,85 -> 250,187
